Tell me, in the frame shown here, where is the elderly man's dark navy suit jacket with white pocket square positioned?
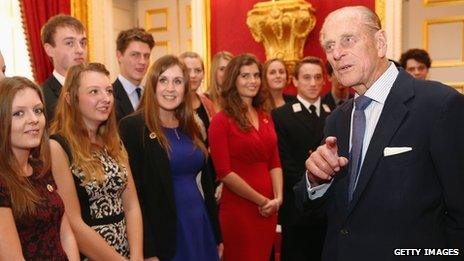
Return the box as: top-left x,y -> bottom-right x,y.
295,70 -> 464,261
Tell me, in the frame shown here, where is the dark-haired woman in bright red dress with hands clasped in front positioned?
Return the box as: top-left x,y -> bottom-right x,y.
209,54 -> 282,261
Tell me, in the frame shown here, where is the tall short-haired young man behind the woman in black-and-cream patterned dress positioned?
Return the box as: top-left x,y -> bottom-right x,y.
41,15 -> 87,122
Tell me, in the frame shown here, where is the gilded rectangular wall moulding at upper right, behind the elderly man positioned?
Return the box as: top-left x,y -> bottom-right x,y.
422,16 -> 464,67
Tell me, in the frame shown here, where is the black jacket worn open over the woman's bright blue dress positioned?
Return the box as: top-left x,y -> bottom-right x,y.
120,114 -> 222,259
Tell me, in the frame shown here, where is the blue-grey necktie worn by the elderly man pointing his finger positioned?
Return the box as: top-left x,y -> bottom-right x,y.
348,95 -> 372,201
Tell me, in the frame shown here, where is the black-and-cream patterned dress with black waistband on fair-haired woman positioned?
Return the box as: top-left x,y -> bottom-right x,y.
52,136 -> 129,257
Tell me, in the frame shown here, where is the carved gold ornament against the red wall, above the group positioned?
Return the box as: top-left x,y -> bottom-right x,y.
247,0 -> 316,79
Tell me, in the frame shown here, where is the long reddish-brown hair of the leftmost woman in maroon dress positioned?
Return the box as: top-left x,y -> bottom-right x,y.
0,77 -> 50,218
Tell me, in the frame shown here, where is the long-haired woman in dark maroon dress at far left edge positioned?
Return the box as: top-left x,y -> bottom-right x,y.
0,77 -> 79,260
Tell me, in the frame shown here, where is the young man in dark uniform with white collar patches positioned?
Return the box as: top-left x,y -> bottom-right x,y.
272,57 -> 330,261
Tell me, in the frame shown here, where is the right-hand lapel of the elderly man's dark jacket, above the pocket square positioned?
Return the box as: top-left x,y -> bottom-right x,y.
348,71 -> 414,214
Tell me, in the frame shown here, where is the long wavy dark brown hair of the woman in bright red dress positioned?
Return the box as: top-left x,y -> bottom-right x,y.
221,54 -> 270,131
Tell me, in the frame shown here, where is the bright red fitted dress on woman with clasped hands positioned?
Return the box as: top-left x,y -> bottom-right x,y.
208,112 -> 280,261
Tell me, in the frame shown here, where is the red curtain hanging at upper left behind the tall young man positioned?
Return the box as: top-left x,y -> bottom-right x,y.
20,0 -> 71,84
